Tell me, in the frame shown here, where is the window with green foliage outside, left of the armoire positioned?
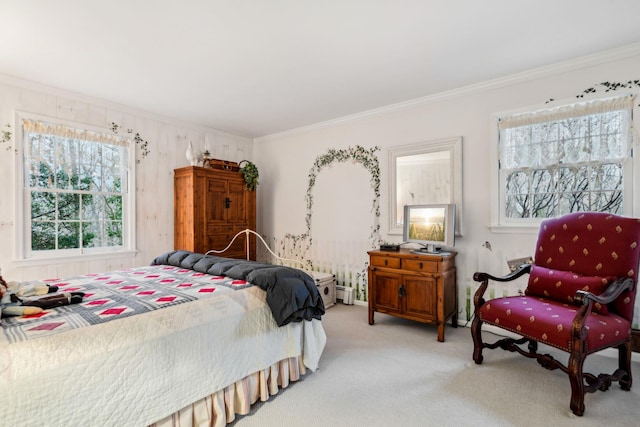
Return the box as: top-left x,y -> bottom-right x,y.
22,115 -> 134,258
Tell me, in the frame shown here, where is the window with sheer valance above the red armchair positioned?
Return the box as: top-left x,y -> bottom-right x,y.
497,95 -> 633,225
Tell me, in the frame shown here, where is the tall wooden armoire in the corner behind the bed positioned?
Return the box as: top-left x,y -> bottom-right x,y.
173,166 -> 256,260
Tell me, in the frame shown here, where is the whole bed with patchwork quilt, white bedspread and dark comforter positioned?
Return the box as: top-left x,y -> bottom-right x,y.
0,246 -> 326,426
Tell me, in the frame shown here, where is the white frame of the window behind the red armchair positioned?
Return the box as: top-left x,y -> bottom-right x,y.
489,91 -> 640,233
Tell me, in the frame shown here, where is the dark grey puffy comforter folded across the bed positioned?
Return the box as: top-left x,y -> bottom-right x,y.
151,250 -> 325,326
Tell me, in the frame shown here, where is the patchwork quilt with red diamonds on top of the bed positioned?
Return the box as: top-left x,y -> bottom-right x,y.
0,265 -> 253,343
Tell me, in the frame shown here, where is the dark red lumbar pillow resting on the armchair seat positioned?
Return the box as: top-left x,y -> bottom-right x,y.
525,265 -> 615,314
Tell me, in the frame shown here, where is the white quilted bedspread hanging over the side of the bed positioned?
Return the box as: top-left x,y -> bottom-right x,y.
0,280 -> 326,427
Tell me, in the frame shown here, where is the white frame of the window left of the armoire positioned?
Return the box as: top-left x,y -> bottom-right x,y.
14,112 -> 137,265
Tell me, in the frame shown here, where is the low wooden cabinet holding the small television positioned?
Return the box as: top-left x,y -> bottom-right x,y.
368,249 -> 458,341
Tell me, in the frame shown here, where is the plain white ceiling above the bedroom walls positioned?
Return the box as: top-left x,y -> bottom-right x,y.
0,0 -> 640,137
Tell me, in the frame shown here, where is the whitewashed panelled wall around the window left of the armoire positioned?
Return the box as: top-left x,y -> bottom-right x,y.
0,76 -> 253,280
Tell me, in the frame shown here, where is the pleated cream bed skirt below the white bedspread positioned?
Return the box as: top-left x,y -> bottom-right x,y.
150,356 -> 306,427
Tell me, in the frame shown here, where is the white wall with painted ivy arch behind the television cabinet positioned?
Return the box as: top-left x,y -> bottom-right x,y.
254,51 -> 640,318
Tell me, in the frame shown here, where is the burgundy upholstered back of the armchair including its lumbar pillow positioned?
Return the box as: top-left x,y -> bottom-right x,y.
526,212 -> 640,321
